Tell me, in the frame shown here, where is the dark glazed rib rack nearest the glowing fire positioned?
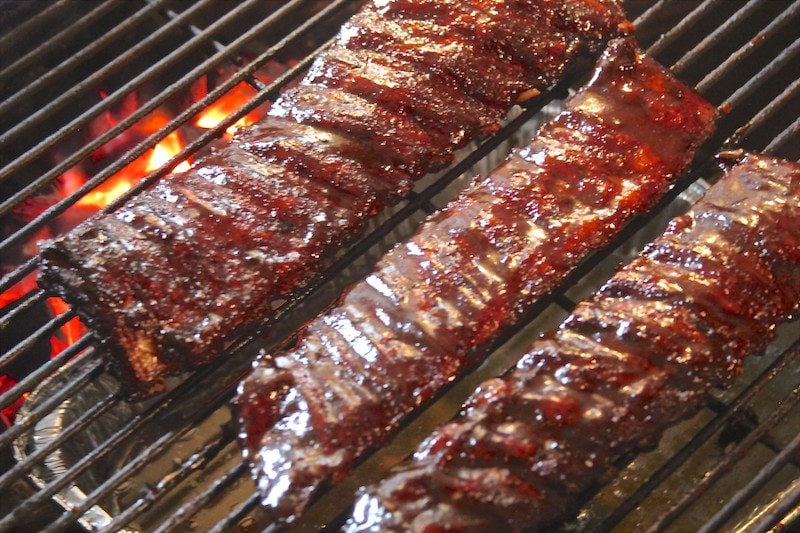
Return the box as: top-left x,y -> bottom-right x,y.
40,0 -> 630,393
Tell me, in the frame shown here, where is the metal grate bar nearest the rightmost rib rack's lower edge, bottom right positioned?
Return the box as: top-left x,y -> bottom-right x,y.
600,344 -> 800,531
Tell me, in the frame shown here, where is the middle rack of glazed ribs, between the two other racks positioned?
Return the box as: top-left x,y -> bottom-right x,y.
238,39 -> 715,518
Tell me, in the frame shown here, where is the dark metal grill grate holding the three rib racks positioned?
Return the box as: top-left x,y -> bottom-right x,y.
0,0 -> 800,531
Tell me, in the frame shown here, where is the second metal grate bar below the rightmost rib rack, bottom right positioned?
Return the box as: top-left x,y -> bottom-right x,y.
650,387 -> 800,531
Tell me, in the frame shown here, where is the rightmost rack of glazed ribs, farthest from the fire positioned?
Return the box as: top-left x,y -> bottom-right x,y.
346,155 -> 800,531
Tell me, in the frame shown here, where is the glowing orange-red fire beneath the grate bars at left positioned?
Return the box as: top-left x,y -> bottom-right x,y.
0,62 -> 276,425
